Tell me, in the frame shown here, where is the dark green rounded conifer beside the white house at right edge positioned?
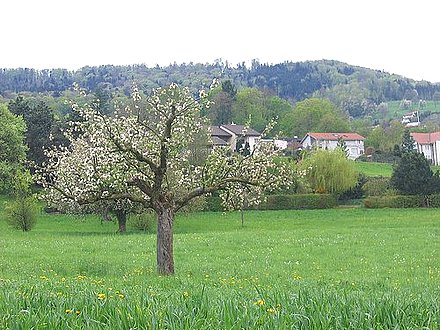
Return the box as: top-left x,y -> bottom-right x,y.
391,152 -> 440,195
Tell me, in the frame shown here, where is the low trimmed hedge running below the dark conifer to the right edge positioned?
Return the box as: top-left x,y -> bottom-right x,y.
364,195 -> 440,209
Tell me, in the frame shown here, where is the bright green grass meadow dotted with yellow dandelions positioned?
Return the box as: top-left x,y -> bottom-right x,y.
0,208 -> 440,329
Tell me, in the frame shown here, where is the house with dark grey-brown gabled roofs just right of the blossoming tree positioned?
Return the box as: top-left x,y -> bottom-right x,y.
210,124 -> 261,151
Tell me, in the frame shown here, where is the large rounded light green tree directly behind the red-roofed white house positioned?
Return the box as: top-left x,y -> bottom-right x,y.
281,98 -> 350,137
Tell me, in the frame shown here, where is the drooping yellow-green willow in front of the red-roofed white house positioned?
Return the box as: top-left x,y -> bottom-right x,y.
300,148 -> 358,194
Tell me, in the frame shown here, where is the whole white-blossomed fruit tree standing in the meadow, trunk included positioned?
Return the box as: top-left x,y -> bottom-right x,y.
40,84 -> 289,274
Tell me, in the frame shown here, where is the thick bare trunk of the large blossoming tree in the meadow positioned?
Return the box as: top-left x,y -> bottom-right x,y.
156,205 -> 174,275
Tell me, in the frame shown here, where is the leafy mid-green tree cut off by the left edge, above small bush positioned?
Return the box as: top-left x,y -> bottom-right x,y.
0,104 -> 27,193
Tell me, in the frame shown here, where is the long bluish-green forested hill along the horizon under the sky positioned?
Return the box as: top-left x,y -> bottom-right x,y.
0,60 -> 440,117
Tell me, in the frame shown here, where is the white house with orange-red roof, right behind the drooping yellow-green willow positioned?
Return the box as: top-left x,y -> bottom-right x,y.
301,133 -> 365,159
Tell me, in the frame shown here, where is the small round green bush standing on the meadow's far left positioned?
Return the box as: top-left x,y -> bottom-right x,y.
5,196 -> 38,231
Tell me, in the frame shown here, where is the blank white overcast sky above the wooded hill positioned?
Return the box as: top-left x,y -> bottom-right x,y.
0,0 -> 440,82
